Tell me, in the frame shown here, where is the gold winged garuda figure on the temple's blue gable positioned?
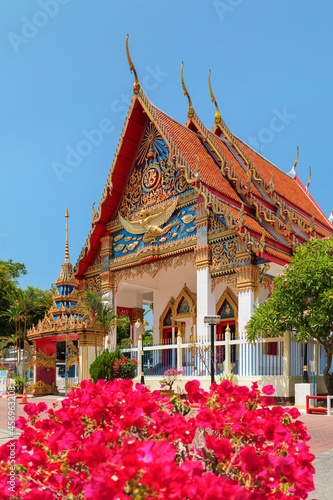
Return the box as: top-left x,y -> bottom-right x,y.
119,196 -> 178,243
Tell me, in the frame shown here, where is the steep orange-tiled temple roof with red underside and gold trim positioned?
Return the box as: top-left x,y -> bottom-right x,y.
75,89 -> 333,278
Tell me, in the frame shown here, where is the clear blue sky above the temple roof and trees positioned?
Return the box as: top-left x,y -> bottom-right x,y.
0,0 -> 333,288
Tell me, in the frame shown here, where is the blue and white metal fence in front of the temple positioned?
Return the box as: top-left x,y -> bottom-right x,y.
118,337 -> 326,377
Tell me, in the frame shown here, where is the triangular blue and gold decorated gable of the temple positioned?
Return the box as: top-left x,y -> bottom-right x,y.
109,123 -> 196,258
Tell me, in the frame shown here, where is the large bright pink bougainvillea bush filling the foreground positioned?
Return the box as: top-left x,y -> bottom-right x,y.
0,379 -> 314,500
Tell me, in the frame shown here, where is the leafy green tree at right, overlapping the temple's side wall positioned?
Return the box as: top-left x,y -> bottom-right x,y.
247,238 -> 333,395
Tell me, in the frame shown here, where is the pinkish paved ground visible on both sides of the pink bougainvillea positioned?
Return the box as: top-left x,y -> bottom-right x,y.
0,395 -> 333,500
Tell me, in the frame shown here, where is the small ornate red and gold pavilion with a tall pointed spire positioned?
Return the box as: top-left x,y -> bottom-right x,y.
26,207 -> 103,394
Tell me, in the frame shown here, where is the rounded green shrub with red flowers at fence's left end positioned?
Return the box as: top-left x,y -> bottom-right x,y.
89,347 -> 137,383
